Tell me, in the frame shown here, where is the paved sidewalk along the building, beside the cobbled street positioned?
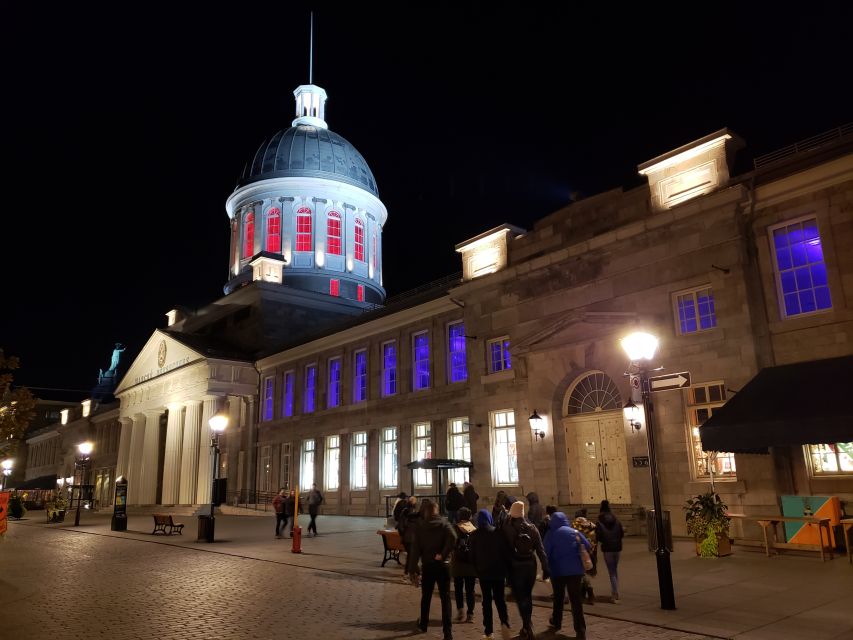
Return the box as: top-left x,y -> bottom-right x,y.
11,512 -> 853,640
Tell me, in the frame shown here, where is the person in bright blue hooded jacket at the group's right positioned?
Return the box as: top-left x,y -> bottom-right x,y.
545,511 -> 592,640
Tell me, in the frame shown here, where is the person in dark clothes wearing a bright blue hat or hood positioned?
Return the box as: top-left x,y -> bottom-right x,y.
471,509 -> 511,640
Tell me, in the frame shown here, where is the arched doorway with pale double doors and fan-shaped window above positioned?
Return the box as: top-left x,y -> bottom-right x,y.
563,371 -> 631,504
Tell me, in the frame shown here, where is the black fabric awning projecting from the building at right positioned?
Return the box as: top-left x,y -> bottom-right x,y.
699,356 -> 853,453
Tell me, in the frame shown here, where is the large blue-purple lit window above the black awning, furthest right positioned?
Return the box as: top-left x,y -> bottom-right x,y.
771,218 -> 832,318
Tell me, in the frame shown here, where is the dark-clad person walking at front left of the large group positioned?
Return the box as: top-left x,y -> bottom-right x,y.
412,498 -> 456,640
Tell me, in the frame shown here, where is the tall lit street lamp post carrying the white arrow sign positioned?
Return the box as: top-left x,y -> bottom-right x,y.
622,332 -> 675,609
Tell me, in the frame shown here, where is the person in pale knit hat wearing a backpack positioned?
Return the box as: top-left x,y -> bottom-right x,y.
503,502 -> 550,640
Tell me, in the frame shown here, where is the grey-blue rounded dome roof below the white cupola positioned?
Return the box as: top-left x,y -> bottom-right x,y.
239,124 -> 379,196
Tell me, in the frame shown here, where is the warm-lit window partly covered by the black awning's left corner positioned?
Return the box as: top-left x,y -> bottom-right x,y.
687,382 -> 737,480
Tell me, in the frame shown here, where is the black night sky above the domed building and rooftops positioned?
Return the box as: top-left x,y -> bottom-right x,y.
0,2 -> 853,397
